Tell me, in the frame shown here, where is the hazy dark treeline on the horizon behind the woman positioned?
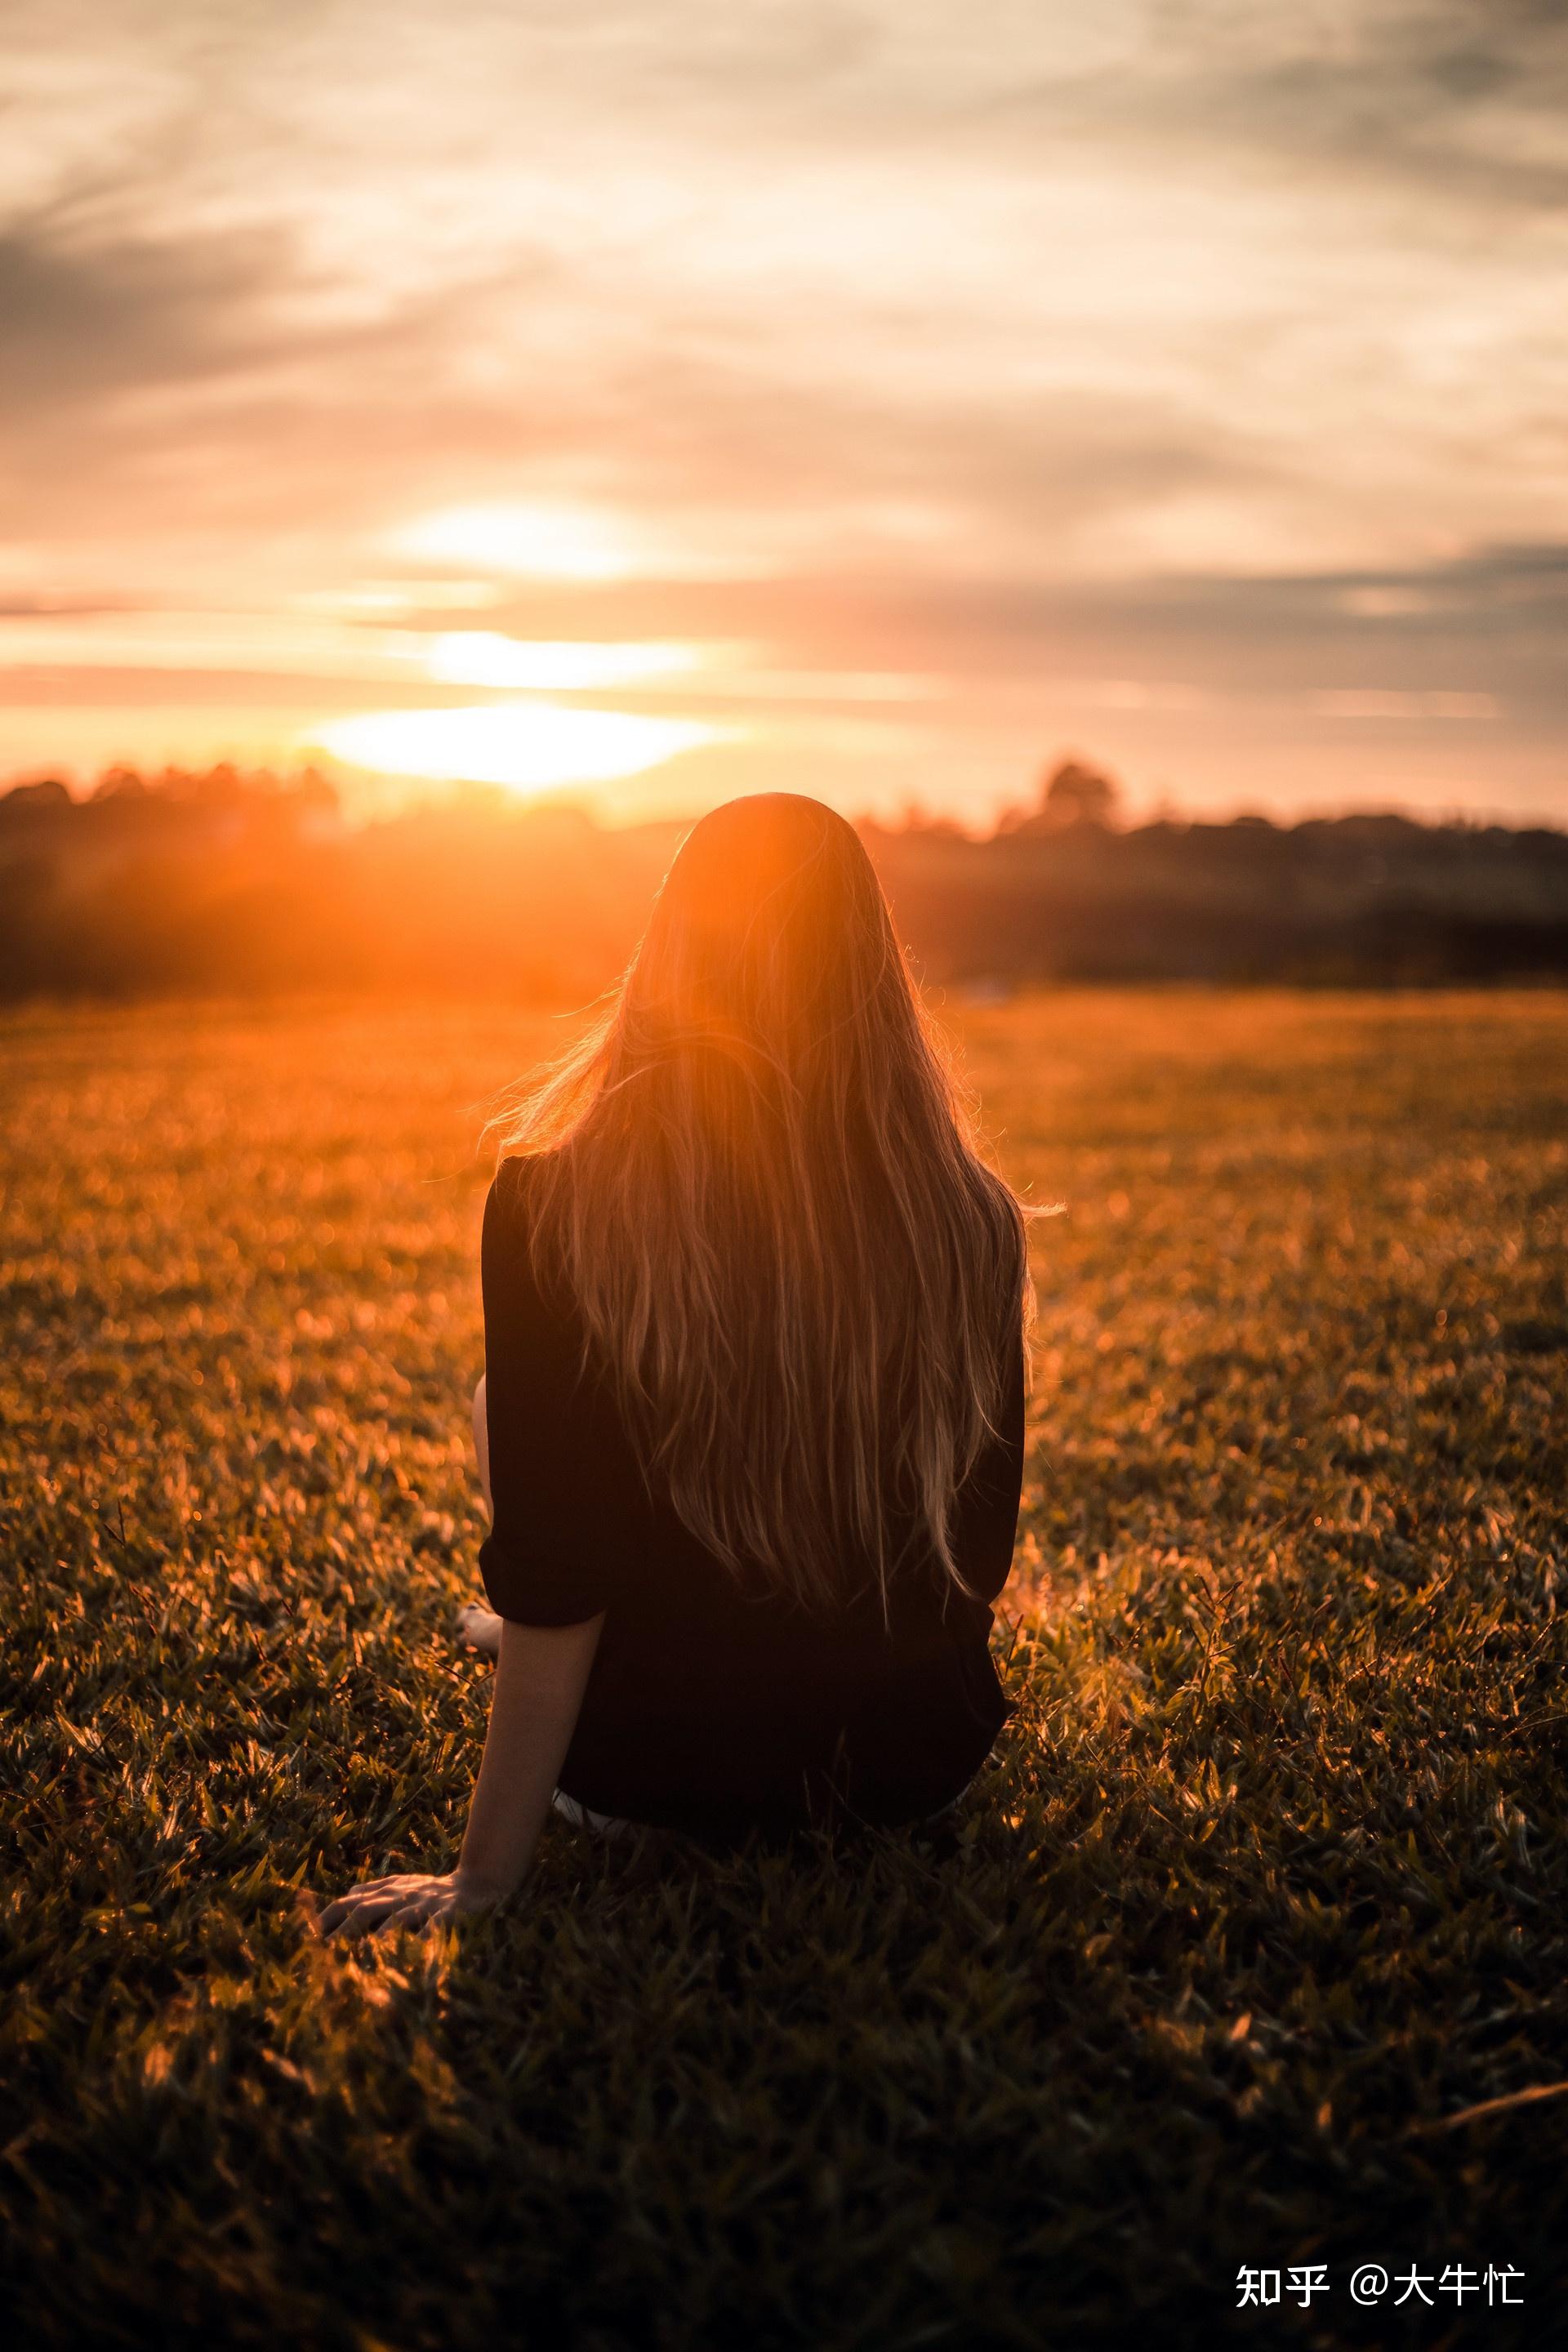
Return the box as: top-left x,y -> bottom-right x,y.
0,764 -> 1568,1002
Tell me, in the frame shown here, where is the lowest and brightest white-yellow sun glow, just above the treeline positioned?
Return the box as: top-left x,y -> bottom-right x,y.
308,703 -> 733,793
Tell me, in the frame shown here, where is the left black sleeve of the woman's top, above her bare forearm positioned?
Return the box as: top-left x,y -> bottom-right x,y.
479,1160 -> 647,1625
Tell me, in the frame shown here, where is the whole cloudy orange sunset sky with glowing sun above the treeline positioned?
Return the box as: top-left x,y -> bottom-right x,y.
0,0 -> 1568,823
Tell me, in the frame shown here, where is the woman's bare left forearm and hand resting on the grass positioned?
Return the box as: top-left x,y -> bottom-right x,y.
322,1616 -> 604,1936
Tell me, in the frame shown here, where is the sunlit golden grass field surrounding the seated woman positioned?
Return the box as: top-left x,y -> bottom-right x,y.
0,990 -> 1568,2352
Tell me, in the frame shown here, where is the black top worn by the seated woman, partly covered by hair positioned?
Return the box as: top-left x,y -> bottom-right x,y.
479,1160 -> 1022,1837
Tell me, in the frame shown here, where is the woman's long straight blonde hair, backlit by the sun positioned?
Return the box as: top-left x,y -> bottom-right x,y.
489,793 -> 1032,1606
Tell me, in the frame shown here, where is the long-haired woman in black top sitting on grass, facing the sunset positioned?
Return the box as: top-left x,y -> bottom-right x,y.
322,793 -> 1032,1931
